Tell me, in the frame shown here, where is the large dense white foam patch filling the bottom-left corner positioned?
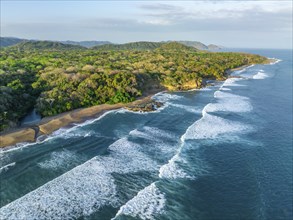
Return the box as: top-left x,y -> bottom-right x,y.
0,159 -> 117,220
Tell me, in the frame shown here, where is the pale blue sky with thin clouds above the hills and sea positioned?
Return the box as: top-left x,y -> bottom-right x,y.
0,0 -> 293,49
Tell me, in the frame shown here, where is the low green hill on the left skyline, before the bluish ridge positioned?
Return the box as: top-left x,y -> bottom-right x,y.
10,41 -> 86,50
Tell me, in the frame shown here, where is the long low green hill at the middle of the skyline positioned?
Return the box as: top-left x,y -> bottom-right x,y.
92,41 -> 164,50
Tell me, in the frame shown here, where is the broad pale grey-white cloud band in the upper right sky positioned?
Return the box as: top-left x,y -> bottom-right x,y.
137,4 -> 292,32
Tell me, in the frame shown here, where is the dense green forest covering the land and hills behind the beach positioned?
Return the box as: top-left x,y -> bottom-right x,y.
0,41 -> 267,131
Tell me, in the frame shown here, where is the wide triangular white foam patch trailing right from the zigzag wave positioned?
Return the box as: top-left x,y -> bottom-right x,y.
185,113 -> 251,140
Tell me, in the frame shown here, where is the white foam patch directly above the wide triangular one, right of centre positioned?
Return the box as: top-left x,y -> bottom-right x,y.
205,91 -> 253,112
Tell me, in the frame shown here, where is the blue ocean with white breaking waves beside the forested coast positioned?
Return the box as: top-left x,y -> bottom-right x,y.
0,49 -> 293,220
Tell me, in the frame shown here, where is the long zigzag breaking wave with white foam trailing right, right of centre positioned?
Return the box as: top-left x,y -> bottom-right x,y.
159,72 -> 252,179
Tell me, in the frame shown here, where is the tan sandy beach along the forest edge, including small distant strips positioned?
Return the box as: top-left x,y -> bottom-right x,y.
0,58 -> 277,148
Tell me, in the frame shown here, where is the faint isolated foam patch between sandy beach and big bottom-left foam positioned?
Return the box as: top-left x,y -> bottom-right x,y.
38,150 -> 80,170
